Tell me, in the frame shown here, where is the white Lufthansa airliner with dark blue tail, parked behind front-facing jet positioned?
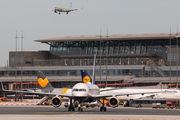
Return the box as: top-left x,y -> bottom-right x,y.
81,70 -> 180,102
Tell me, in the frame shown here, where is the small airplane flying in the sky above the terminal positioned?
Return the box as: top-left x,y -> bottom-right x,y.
52,3 -> 82,14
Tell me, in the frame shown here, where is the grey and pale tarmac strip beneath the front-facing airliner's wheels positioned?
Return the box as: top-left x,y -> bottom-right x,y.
0,105 -> 180,120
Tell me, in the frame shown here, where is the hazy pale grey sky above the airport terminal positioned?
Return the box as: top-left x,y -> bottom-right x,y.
0,0 -> 180,66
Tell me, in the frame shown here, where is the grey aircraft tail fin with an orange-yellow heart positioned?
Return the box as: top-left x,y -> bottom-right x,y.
37,71 -> 54,91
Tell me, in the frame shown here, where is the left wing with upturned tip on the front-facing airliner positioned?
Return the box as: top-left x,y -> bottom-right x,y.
1,81 -> 72,97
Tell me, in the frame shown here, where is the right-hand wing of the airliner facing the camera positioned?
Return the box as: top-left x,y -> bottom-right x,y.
90,91 -> 160,98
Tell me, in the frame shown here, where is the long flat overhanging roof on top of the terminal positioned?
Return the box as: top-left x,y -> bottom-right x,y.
34,33 -> 179,43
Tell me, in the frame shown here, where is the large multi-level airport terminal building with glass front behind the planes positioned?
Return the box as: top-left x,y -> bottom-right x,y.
0,33 -> 180,88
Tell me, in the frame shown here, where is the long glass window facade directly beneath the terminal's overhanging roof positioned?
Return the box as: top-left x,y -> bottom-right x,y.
50,39 -> 176,59
